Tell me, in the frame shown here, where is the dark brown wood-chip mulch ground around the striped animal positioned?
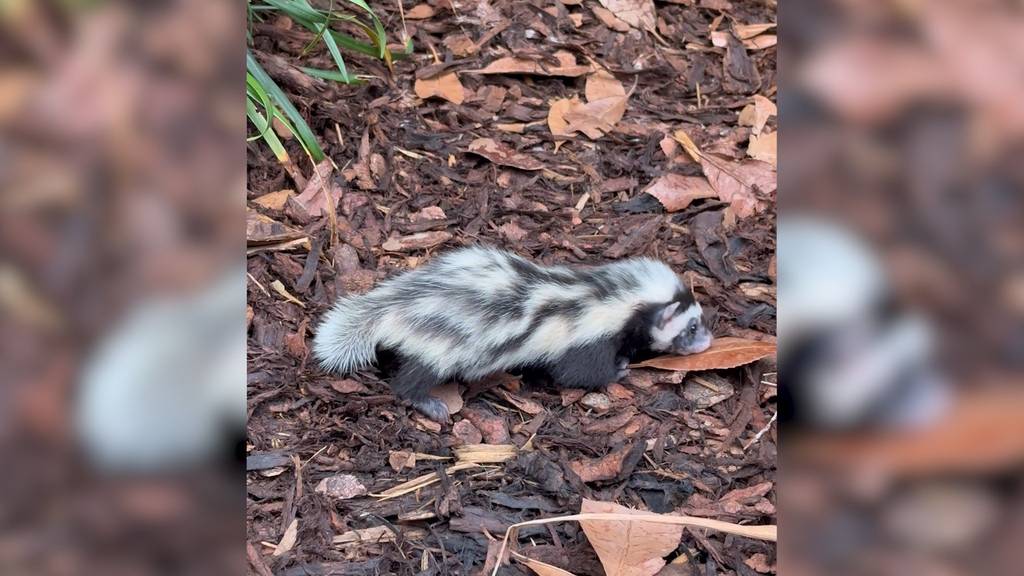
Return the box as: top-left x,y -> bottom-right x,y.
247,0 -> 776,575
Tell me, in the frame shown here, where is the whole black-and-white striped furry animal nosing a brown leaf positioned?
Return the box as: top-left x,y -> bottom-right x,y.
313,247 -> 712,420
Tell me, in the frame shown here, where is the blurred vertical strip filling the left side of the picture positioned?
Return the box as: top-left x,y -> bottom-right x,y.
0,0 -> 246,574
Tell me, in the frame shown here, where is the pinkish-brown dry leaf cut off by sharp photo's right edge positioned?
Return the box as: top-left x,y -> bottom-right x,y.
700,155 -> 778,218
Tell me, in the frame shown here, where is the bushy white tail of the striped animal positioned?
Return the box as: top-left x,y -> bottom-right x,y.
313,295 -> 378,373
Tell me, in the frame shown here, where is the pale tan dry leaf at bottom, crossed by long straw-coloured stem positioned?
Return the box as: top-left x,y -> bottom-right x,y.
580,498 -> 683,576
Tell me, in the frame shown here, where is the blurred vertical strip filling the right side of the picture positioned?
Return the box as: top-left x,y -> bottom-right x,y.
778,0 -> 1024,575
